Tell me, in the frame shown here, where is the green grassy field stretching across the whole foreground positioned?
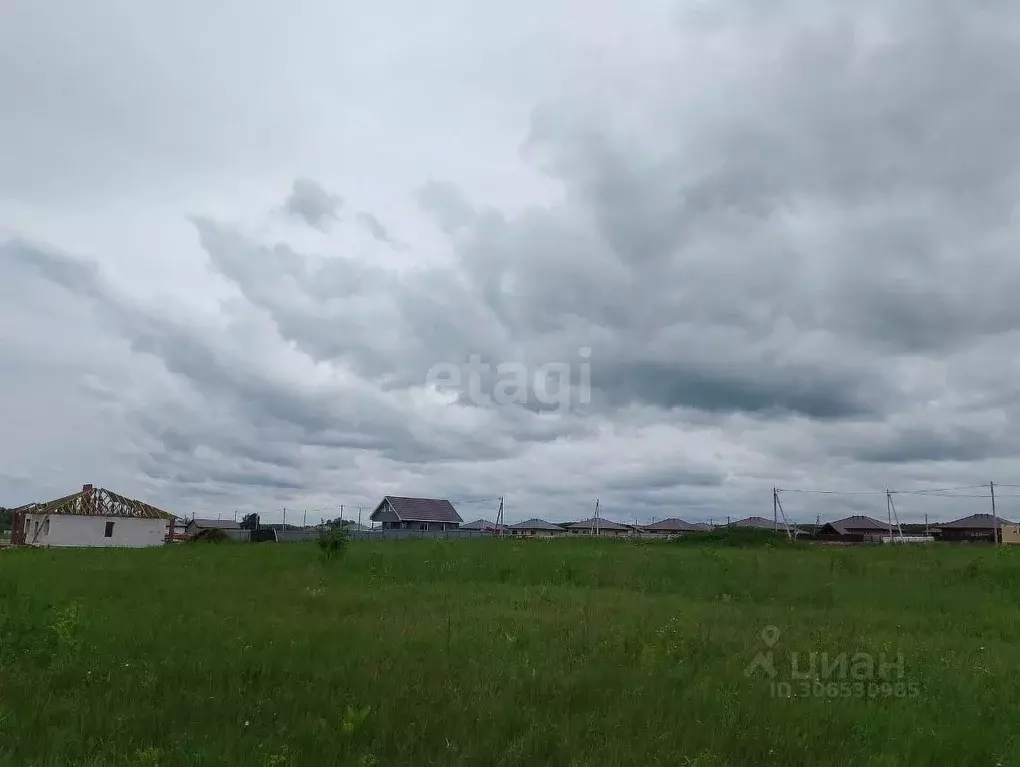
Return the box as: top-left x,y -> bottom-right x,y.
0,540 -> 1020,767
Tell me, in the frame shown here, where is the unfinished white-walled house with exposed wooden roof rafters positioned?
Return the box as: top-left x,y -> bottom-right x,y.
11,484 -> 176,548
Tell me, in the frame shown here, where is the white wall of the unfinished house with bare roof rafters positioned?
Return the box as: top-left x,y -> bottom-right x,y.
24,514 -> 170,548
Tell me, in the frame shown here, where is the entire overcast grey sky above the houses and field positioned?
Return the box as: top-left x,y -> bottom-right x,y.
0,0 -> 1020,521
